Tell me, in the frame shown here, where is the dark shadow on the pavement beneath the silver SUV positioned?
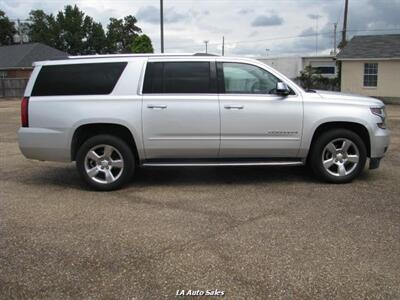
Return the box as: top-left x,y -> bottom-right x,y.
18,165 -> 319,190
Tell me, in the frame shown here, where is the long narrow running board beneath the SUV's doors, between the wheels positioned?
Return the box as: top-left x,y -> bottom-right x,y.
142,161 -> 304,167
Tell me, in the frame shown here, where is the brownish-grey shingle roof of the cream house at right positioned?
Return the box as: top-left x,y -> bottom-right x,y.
337,34 -> 400,60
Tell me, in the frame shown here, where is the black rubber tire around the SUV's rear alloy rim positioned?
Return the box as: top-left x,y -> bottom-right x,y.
76,134 -> 135,191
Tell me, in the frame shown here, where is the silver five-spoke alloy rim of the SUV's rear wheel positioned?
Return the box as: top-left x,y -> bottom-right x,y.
85,145 -> 124,184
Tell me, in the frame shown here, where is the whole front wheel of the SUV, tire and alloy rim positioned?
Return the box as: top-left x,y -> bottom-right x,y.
310,129 -> 367,183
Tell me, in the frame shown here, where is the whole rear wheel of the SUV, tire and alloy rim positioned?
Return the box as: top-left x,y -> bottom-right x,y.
76,135 -> 135,191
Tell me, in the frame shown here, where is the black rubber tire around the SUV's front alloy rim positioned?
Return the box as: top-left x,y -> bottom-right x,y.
308,129 -> 367,183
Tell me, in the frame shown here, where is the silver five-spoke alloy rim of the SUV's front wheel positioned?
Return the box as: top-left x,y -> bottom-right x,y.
322,138 -> 360,177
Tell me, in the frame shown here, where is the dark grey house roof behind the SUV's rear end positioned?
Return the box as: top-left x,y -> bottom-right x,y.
0,43 -> 68,69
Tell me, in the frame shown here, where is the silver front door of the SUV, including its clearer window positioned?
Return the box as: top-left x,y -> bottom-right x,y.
217,62 -> 303,158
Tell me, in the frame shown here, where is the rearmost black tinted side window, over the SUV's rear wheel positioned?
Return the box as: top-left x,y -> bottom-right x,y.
32,62 -> 127,96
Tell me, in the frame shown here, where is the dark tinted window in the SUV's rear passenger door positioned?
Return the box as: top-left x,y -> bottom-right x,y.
143,62 -> 212,94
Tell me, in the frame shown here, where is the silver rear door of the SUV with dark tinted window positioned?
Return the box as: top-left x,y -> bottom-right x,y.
142,59 -> 220,159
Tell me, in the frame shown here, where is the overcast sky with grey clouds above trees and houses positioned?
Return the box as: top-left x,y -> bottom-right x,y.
0,0 -> 400,56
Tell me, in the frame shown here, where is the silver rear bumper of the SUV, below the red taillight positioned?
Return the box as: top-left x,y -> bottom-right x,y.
18,127 -> 71,162
